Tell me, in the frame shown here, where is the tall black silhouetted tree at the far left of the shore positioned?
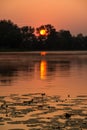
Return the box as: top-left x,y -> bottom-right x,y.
0,20 -> 22,50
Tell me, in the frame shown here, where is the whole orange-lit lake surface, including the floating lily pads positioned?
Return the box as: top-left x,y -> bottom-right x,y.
0,52 -> 87,130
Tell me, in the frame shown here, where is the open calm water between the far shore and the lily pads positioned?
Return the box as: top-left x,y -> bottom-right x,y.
0,52 -> 87,96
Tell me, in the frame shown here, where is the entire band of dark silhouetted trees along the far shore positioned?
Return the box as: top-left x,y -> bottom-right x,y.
0,20 -> 87,51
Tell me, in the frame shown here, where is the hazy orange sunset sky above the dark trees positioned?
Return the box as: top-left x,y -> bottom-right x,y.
0,0 -> 87,35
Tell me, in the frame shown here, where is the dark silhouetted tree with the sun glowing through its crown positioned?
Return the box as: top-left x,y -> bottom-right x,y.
36,24 -> 57,50
